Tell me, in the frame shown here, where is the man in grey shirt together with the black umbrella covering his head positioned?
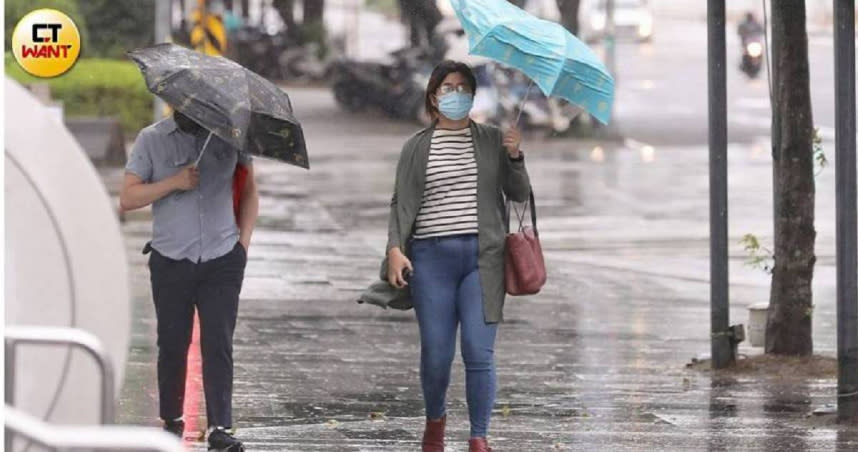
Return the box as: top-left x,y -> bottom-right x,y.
120,44 -> 309,452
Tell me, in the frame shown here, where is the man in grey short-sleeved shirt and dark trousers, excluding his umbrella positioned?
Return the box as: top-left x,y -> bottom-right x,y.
120,107 -> 254,451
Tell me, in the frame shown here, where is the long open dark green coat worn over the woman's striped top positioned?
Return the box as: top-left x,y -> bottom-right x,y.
358,122 -> 530,323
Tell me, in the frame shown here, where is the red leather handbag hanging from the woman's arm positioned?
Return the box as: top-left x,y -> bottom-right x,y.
504,190 -> 548,295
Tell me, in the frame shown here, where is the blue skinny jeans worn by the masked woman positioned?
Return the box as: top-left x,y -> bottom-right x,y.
410,235 -> 497,438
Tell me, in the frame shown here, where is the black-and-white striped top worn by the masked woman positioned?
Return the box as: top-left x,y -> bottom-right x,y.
414,128 -> 478,239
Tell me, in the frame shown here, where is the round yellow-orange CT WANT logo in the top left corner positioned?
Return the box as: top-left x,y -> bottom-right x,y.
12,9 -> 80,77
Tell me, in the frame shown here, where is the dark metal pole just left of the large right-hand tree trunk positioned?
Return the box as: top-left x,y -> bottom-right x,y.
708,0 -> 735,369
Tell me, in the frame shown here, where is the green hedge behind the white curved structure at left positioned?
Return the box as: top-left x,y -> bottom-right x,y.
5,53 -> 153,136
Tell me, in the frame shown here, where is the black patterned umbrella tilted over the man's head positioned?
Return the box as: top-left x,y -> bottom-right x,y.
128,44 -> 310,169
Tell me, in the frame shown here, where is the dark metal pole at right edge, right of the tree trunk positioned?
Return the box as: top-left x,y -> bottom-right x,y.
834,0 -> 858,423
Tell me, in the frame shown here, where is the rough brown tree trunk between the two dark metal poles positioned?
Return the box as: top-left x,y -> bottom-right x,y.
766,1 -> 816,355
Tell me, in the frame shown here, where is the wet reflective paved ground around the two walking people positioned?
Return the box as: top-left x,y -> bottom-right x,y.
119,89 -> 858,451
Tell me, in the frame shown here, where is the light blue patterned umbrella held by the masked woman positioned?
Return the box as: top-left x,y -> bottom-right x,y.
451,0 -> 614,124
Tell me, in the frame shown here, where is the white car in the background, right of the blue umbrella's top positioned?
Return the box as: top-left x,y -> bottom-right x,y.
579,0 -> 653,43
